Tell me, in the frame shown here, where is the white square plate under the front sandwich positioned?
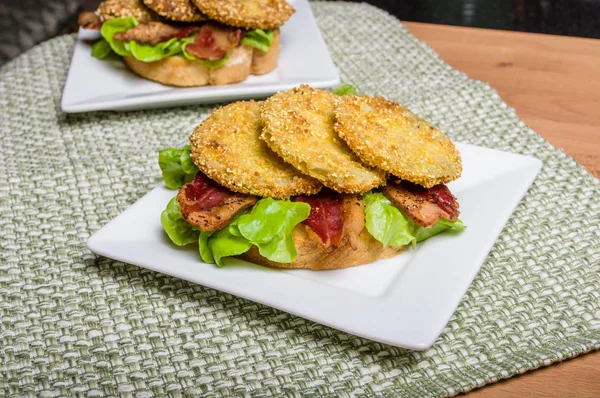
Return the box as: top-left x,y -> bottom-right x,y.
87,144 -> 542,350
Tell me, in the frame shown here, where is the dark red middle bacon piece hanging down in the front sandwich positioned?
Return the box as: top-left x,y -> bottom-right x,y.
296,191 -> 344,248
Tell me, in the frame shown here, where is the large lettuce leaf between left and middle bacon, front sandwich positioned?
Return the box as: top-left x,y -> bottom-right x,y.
198,198 -> 310,266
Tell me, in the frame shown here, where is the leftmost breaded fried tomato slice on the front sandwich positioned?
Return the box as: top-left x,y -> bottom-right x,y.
190,101 -> 321,199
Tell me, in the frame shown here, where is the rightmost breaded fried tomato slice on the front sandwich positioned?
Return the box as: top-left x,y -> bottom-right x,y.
334,95 -> 462,188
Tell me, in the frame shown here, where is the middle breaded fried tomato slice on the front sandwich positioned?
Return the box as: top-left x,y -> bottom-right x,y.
260,85 -> 385,193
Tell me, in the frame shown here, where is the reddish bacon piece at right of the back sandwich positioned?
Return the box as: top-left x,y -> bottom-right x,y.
185,23 -> 243,61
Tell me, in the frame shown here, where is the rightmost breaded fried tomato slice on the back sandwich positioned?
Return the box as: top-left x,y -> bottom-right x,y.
192,0 -> 295,29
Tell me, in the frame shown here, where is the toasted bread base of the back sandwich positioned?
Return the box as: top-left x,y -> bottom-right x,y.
123,35 -> 279,87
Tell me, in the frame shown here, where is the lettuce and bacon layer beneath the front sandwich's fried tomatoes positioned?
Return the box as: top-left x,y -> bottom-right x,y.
159,147 -> 465,266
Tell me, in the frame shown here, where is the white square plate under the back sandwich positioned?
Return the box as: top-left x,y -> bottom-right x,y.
61,0 -> 340,113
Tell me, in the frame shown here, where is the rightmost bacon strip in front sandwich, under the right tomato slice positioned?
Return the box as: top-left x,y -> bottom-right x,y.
383,181 -> 460,228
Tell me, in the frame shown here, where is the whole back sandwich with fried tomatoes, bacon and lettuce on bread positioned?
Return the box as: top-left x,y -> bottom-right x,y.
78,0 -> 294,87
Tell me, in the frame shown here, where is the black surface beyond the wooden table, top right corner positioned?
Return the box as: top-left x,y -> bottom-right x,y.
352,0 -> 600,38
